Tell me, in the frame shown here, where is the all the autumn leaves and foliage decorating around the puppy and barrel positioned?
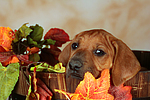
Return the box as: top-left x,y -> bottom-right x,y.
0,24 -> 132,100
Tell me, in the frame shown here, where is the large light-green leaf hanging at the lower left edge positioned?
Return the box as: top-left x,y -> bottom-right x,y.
0,63 -> 20,100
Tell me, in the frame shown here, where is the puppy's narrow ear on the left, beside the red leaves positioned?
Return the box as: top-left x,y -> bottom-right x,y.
58,43 -> 71,67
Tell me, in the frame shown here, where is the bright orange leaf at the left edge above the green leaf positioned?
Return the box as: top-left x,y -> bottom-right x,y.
0,27 -> 15,52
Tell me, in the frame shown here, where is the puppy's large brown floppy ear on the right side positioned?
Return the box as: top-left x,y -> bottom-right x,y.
112,40 -> 141,86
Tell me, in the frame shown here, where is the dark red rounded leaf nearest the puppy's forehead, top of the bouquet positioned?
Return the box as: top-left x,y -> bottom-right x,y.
44,28 -> 70,47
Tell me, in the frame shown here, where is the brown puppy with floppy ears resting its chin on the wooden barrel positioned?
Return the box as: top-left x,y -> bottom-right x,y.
59,29 -> 141,86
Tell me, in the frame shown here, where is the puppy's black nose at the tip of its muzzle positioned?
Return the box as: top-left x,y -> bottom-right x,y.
69,60 -> 83,70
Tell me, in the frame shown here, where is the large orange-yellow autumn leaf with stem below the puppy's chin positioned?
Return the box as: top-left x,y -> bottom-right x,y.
55,69 -> 114,100
